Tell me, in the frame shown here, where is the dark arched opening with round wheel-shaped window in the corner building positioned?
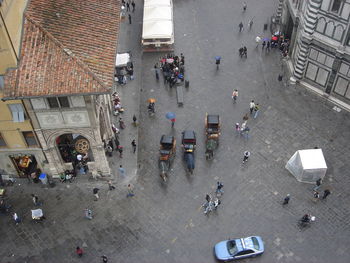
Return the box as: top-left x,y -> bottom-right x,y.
56,133 -> 93,174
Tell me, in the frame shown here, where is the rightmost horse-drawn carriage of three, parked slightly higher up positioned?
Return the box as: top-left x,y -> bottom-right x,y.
205,113 -> 221,160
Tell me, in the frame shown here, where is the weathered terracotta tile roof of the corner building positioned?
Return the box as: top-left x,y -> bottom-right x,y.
5,0 -> 120,97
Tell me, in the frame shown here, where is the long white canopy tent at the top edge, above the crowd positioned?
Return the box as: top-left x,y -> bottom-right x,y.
142,0 -> 174,44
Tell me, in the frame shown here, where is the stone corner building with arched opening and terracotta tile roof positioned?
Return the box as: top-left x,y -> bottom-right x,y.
3,0 -> 120,177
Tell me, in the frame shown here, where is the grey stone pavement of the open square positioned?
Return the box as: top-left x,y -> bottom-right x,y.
0,0 -> 350,263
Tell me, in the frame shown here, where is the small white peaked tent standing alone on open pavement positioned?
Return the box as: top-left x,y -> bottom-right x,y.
286,149 -> 327,183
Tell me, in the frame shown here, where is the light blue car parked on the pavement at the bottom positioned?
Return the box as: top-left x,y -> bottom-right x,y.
214,236 -> 264,261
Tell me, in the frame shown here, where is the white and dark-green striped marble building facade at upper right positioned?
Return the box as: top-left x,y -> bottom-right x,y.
282,0 -> 350,105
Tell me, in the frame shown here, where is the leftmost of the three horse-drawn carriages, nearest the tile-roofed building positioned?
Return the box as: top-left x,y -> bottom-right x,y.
158,135 -> 176,182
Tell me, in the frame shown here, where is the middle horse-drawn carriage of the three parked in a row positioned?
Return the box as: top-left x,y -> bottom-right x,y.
182,130 -> 197,174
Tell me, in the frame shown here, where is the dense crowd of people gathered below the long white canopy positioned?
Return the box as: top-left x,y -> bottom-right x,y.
159,53 -> 185,88
